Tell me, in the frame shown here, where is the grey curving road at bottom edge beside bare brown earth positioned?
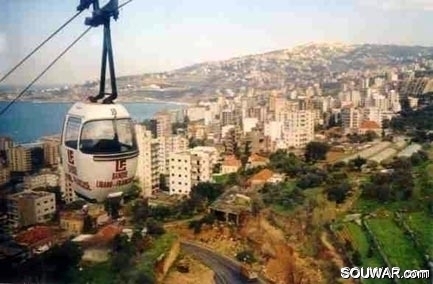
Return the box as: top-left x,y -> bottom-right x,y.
181,242 -> 264,284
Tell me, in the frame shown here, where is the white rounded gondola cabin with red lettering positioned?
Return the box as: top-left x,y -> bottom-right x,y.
61,103 -> 138,202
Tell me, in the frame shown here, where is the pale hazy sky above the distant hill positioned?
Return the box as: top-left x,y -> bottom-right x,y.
0,0 -> 433,85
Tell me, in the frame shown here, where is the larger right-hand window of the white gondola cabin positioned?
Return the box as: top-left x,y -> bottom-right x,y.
80,118 -> 137,154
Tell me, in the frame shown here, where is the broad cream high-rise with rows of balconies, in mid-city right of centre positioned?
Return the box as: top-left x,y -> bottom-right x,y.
284,110 -> 315,148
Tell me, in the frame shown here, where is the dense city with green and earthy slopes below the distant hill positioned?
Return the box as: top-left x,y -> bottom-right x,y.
0,59 -> 433,283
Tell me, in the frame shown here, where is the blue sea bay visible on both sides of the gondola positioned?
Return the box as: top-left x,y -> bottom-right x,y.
0,102 -> 185,144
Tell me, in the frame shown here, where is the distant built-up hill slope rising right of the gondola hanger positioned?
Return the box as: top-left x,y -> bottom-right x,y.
113,44 -> 433,101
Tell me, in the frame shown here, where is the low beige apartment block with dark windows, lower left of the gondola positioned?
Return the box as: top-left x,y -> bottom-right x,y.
7,191 -> 56,229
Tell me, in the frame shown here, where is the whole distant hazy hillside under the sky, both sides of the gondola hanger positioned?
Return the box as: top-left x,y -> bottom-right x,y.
3,44 -> 433,102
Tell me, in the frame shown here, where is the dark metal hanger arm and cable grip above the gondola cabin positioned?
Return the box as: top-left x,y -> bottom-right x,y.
77,0 -> 119,104
